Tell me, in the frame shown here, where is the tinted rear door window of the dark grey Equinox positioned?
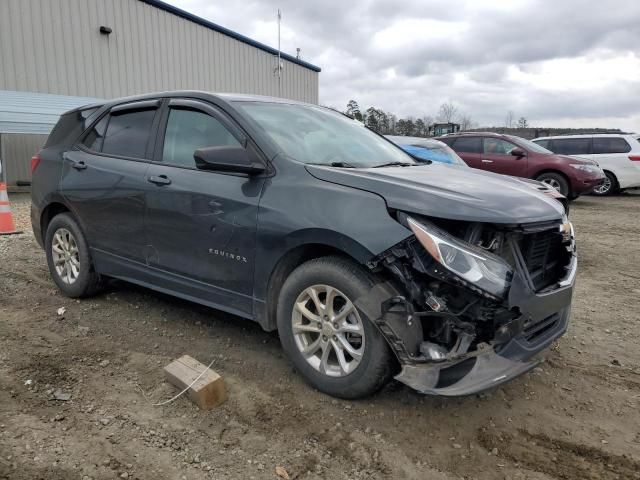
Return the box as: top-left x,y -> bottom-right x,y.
101,108 -> 156,158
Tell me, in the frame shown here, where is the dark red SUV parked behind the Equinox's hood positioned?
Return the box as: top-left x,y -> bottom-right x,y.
438,132 -> 605,200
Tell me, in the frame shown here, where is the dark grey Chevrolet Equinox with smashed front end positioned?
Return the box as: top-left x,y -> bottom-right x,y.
31,91 -> 577,398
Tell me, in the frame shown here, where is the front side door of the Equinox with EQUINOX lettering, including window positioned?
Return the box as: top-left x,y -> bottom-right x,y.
145,99 -> 264,316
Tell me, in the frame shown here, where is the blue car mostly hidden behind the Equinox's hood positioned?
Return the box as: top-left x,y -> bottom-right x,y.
385,135 -> 569,215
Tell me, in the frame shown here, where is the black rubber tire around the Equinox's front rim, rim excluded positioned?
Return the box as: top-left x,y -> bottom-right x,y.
277,257 -> 397,399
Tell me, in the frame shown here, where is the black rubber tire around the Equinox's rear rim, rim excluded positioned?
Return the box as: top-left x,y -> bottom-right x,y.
44,213 -> 102,298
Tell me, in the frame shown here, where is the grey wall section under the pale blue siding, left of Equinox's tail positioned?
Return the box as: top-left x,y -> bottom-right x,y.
0,134 -> 47,185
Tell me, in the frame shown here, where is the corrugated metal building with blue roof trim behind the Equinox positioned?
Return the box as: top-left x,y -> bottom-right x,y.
0,0 -> 320,184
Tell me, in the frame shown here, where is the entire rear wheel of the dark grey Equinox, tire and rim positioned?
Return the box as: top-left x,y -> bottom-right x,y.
44,213 -> 102,298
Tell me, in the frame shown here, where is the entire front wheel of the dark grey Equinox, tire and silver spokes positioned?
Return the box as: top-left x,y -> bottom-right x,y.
277,257 -> 396,399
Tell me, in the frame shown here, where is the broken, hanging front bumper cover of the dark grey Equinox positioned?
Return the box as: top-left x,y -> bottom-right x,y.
356,249 -> 577,396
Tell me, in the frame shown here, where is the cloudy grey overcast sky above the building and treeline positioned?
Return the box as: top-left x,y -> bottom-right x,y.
168,0 -> 640,132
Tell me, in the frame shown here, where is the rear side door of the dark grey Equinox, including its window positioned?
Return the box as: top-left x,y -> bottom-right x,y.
60,100 -> 160,261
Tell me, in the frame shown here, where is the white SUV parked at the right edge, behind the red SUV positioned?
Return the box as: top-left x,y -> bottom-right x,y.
533,133 -> 640,195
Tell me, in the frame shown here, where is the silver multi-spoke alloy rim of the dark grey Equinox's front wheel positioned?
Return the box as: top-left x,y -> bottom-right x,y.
291,285 -> 365,377
